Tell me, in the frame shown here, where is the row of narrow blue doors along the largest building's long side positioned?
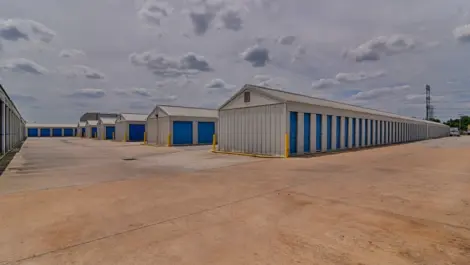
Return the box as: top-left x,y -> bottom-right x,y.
289,112 -> 410,154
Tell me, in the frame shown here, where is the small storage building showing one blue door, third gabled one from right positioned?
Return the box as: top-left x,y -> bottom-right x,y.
115,113 -> 147,142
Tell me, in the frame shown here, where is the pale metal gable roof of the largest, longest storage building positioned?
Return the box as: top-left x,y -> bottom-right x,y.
219,84 -> 442,125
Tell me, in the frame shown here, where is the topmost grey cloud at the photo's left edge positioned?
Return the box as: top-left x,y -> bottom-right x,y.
0,19 -> 56,43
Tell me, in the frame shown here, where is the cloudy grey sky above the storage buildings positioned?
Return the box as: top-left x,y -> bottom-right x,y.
0,0 -> 470,123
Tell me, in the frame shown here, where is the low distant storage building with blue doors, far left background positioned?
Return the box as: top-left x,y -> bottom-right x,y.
26,123 -> 77,137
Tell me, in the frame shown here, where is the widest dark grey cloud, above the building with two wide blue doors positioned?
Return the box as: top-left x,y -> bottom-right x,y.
129,51 -> 213,76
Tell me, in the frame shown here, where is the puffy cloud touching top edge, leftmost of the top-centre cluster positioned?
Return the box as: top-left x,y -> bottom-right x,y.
138,0 -> 173,26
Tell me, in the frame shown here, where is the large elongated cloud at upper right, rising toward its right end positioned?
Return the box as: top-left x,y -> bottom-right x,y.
344,35 -> 416,62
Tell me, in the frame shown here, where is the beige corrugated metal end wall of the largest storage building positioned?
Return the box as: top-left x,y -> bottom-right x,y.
218,104 -> 286,156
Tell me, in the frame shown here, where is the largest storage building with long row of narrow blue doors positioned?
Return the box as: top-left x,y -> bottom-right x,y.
217,85 -> 449,156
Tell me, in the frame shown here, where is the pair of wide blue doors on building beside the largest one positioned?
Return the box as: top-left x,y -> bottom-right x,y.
173,121 -> 215,145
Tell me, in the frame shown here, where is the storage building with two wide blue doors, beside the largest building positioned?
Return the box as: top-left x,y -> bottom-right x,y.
147,105 -> 218,145
